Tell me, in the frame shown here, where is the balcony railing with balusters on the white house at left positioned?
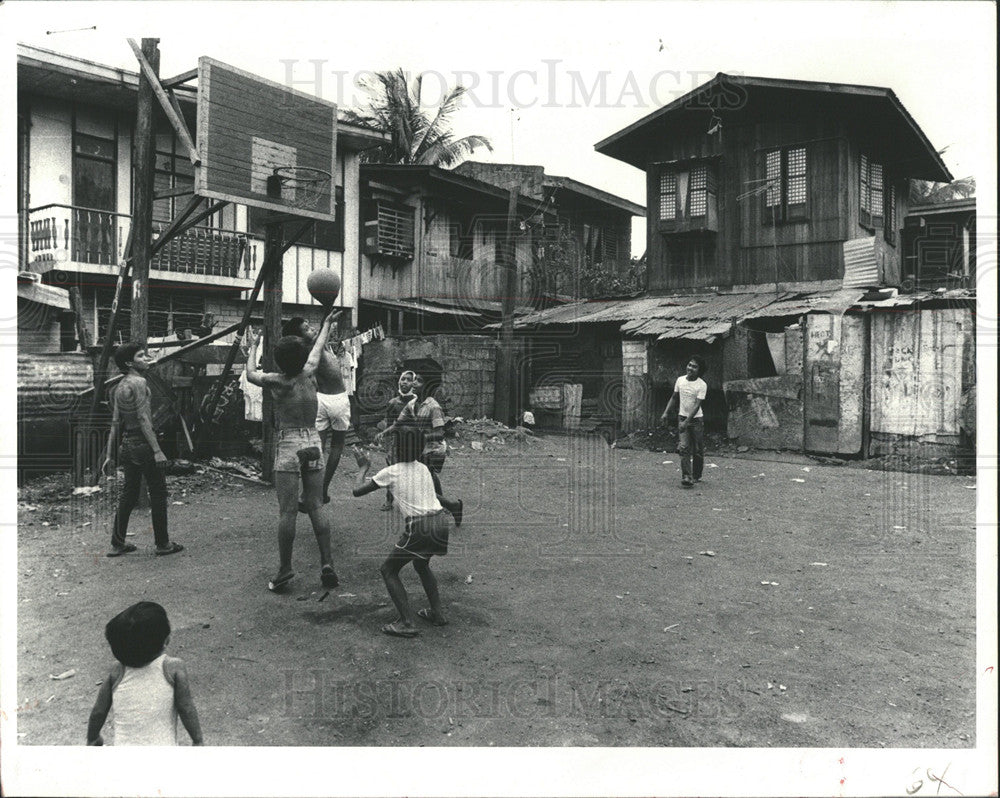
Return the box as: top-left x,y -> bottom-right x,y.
29,205 -> 260,279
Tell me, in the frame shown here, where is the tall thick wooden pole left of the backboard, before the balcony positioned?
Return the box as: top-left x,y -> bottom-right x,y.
130,39 -> 160,346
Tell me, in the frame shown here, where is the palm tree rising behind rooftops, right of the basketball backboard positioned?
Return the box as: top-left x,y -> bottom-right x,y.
347,69 -> 493,167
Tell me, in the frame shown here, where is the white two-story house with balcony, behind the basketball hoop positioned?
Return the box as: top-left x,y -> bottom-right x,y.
17,45 -> 390,478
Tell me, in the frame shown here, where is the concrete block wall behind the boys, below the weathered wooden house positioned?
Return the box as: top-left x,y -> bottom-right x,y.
356,335 -> 496,419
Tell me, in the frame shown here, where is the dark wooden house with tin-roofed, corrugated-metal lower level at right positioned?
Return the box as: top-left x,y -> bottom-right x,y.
518,73 -> 974,454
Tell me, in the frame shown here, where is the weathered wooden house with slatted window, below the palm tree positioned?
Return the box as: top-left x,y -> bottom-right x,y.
360,164 -> 547,333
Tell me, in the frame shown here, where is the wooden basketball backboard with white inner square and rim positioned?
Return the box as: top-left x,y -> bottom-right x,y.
195,56 -> 337,221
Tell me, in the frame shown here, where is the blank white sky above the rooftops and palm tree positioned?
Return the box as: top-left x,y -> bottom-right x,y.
2,2 -> 996,255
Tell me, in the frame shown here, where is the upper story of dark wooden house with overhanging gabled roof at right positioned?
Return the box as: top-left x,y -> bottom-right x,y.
595,73 -> 952,292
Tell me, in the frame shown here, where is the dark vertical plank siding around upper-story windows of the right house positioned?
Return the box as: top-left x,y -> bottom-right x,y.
646,92 -> 908,292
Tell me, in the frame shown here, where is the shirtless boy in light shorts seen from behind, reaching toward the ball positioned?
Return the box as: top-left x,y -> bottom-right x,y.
247,311 -> 340,593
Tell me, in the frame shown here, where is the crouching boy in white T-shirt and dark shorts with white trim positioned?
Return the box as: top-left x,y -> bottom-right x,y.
353,427 -> 455,637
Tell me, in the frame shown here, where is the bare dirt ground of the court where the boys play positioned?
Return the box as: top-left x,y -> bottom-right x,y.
17,437 -> 976,748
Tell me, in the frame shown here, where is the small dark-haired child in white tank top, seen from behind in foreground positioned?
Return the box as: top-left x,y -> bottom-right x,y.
87,601 -> 203,745
